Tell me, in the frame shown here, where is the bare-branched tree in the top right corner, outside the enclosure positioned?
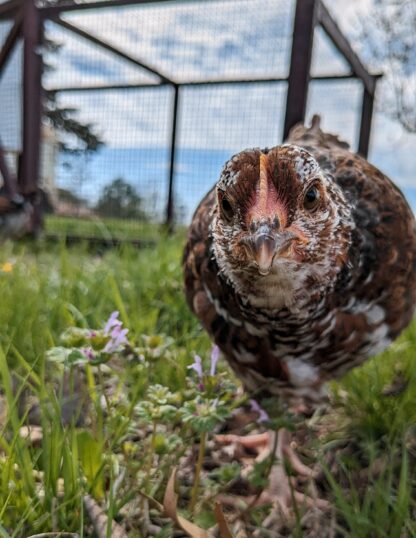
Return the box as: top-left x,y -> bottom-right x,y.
361,0 -> 416,133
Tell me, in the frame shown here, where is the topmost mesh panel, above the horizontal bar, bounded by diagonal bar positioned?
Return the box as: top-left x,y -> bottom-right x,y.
60,0 -> 294,82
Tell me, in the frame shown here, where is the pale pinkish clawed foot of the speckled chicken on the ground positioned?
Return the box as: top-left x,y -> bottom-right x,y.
216,429 -> 330,516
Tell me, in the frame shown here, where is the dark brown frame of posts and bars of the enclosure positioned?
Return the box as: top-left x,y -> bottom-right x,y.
0,0 -> 381,229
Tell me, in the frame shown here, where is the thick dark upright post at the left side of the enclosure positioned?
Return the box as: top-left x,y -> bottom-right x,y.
19,0 -> 43,195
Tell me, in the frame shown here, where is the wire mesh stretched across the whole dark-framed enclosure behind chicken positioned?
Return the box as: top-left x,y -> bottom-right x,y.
0,0 -> 370,238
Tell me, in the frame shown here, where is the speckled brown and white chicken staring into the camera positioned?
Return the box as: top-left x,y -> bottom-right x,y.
183,116 -> 416,510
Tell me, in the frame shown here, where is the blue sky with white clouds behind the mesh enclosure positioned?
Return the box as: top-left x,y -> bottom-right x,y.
0,0 -> 416,218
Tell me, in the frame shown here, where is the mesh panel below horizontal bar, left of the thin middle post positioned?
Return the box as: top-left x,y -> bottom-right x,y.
56,87 -> 173,225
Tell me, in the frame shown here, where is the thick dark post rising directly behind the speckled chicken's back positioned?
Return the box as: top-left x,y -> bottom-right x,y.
283,0 -> 318,140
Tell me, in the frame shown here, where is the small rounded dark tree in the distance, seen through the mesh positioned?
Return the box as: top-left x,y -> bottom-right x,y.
95,178 -> 148,220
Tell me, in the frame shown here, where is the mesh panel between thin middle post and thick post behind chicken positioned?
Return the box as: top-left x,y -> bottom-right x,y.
176,83 -> 286,220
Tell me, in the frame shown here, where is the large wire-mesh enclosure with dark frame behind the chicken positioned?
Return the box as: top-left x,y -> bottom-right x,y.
0,0 -> 379,239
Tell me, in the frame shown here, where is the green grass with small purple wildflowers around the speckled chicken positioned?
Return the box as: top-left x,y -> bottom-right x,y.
0,235 -> 416,538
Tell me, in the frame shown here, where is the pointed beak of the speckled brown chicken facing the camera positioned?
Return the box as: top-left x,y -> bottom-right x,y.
251,229 -> 294,276
